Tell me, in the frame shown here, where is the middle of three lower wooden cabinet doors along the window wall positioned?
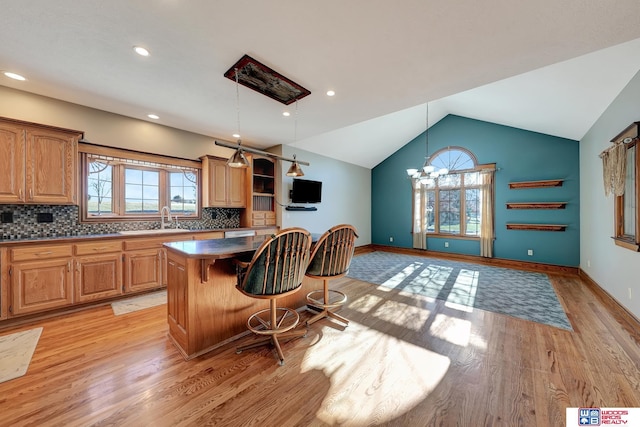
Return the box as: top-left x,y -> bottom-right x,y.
74,253 -> 122,302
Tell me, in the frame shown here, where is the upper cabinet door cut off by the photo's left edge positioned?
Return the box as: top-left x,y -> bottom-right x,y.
0,123 -> 25,203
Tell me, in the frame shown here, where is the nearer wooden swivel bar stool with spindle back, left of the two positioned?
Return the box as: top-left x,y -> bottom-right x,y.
234,228 -> 311,365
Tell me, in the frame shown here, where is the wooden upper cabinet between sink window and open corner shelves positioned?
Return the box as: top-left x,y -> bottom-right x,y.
201,156 -> 247,208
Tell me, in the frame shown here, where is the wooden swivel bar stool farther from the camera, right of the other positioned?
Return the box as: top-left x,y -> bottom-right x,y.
306,224 -> 358,325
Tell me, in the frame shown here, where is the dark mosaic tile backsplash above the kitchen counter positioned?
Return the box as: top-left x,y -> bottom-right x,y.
0,205 -> 240,240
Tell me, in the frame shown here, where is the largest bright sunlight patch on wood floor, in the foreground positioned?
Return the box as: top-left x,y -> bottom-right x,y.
301,322 -> 451,426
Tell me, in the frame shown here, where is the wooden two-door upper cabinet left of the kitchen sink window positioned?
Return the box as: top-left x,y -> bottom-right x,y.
0,119 -> 81,205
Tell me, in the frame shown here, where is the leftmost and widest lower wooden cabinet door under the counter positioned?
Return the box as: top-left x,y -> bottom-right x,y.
11,258 -> 73,315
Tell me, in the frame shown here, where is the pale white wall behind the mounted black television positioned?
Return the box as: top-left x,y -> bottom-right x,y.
278,146 -> 371,246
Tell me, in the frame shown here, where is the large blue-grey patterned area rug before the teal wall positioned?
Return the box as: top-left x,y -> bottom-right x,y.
348,252 -> 573,330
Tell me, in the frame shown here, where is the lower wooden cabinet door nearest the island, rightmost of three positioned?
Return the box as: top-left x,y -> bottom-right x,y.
124,249 -> 162,292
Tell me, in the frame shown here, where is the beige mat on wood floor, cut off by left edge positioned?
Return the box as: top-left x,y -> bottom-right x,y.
0,328 -> 42,383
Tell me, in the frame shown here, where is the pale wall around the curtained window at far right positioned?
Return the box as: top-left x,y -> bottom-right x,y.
580,68 -> 640,318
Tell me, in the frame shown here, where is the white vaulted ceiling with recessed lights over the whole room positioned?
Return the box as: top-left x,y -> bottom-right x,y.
0,0 -> 640,168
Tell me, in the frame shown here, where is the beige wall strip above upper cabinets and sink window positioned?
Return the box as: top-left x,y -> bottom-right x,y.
0,86 -> 238,160
